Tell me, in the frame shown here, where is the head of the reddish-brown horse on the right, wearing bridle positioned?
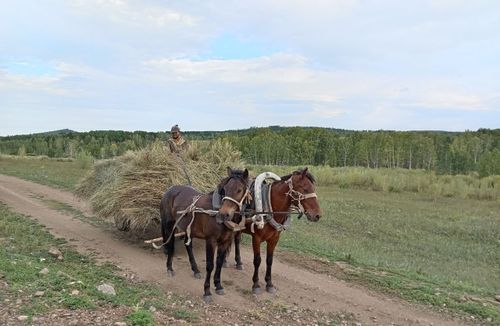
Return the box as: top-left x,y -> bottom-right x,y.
283,168 -> 321,222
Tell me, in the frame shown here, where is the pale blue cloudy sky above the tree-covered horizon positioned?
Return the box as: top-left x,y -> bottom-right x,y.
0,0 -> 500,136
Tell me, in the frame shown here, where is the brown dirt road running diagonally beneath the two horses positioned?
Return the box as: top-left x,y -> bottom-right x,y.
0,175 -> 460,325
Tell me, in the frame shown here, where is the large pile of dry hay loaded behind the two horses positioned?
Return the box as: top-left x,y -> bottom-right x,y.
77,140 -> 241,238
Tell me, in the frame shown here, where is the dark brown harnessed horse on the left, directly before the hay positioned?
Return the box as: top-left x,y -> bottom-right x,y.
160,168 -> 249,302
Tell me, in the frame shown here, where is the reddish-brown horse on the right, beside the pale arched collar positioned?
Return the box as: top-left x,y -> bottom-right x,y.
228,168 -> 321,294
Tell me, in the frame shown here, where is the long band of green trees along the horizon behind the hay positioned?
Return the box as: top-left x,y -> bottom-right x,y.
0,126 -> 500,175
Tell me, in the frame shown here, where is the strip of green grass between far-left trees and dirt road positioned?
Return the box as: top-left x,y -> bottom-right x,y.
0,155 -> 89,190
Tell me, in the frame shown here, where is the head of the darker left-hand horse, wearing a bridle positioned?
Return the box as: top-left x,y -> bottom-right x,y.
219,167 -> 250,221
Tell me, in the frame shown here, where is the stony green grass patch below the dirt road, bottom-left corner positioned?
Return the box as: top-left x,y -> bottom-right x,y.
0,204 -> 165,316
